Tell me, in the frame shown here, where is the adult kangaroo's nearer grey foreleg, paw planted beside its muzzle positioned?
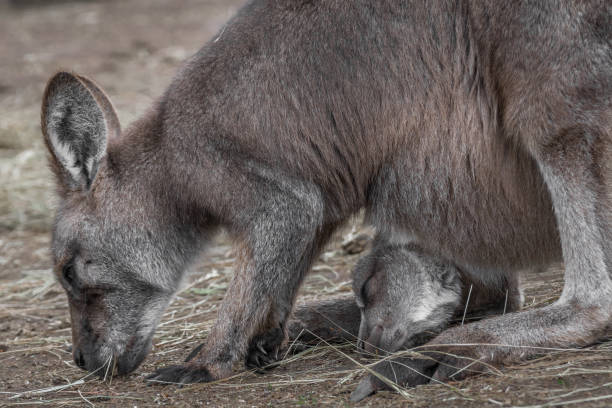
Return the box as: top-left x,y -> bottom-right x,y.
149,181 -> 330,383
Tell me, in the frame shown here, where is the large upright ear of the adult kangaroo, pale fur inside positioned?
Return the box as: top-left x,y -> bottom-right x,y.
41,72 -> 121,191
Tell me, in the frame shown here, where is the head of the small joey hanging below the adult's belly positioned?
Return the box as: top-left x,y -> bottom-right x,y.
353,246 -> 461,352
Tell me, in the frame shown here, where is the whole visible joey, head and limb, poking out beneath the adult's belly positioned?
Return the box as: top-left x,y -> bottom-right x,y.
353,235 -> 522,352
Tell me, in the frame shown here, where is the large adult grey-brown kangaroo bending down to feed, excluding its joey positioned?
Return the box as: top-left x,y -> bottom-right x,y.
42,0 -> 612,398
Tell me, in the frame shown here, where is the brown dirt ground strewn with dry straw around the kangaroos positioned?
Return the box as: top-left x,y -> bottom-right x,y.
0,0 -> 612,407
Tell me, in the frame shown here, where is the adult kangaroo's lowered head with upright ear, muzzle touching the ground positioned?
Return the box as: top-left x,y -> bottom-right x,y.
42,72 -> 194,375
